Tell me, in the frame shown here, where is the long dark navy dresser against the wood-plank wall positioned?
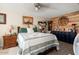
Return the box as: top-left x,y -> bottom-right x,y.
51,31 -> 76,44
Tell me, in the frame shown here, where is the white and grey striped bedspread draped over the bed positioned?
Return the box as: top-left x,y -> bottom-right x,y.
17,26 -> 59,55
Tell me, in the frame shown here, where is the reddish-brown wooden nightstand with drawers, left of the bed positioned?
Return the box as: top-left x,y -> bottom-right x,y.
3,35 -> 17,49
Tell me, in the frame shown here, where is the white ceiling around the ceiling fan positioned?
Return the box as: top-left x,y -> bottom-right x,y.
0,3 -> 79,17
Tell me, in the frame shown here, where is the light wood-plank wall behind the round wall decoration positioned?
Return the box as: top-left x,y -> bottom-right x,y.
51,11 -> 79,30
